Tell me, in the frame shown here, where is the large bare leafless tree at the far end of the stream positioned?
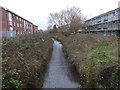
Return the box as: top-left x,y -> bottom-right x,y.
48,6 -> 84,30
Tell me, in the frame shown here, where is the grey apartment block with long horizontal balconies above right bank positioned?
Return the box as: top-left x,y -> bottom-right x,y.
86,8 -> 120,34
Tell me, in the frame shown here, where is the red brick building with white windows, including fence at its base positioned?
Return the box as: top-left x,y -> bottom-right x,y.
0,7 -> 38,36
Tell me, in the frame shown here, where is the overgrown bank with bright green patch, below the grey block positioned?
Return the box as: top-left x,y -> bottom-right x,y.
61,34 -> 120,88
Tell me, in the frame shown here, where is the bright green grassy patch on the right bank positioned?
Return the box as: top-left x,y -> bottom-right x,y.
84,43 -> 118,73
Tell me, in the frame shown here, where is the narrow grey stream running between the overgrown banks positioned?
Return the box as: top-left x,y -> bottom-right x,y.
43,40 -> 80,88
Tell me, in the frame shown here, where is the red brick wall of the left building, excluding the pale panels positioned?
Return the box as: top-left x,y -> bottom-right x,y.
0,7 -> 38,35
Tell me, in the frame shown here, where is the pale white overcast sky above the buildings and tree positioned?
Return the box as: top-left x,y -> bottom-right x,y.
0,0 -> 120,29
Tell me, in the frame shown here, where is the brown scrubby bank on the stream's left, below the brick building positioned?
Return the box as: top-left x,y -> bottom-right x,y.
2,33 -> 52,89
